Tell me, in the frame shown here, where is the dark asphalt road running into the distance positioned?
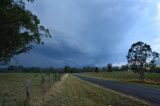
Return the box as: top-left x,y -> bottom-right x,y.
74,74 -> 160,106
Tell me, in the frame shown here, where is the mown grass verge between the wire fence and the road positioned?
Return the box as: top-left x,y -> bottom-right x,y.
45,75 -> 149,106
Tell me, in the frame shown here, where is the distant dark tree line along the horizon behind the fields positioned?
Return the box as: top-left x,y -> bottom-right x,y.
0,63 -> 160,73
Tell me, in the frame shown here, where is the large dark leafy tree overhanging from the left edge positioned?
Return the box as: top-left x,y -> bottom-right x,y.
0,0 -> 51,64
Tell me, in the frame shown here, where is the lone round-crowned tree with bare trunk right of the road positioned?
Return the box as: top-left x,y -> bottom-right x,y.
127,41 -> 159,81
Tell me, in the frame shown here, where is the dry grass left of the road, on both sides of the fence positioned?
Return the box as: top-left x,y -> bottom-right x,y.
0,73 -> 150,106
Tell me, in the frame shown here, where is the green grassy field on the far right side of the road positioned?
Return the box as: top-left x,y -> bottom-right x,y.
81,72 -> 160,88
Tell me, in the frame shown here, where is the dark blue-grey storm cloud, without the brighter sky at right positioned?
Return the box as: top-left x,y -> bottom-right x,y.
12,0 -> 154,66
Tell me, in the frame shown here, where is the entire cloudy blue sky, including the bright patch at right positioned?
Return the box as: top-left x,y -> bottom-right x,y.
11,0 -> 160,67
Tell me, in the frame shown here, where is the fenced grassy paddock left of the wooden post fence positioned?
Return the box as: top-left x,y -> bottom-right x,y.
0,73 -> 61,106
